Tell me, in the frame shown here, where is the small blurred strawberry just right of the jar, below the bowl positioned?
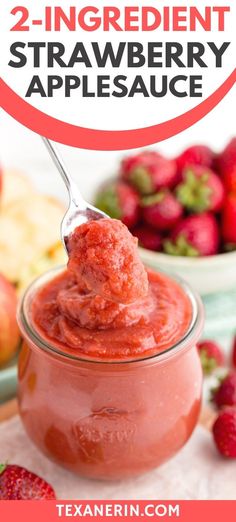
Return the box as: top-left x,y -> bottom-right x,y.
197,339 -> 224,375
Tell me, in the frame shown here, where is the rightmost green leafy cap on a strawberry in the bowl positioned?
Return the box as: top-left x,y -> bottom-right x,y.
176,170 -> 212,213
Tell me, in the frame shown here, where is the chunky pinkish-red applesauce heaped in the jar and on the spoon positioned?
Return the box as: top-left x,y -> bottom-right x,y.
31,219 -> 192,360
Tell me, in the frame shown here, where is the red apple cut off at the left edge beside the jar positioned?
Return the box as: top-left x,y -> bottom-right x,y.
0,274 -> 20,366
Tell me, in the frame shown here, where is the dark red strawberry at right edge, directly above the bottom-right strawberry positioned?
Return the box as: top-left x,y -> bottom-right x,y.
211,372 -> 236,408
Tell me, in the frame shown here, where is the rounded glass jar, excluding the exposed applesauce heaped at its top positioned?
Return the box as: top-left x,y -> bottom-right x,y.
18,270 -> 204,479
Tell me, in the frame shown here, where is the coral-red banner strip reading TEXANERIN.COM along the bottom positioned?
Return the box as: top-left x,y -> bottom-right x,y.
0,500 -> 236,522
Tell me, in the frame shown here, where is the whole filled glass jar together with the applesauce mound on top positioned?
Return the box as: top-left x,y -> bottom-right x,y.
19,219 -> 203,479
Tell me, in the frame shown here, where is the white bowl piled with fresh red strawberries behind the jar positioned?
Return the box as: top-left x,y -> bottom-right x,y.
95,138 -> 236,295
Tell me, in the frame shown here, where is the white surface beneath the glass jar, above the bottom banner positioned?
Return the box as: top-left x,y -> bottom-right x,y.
0,416 -> 236,500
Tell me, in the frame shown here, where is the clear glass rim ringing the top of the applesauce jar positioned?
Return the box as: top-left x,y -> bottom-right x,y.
17,265 -> 204,366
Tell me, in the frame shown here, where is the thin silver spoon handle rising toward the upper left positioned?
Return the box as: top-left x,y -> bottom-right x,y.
41,136 -> 85,208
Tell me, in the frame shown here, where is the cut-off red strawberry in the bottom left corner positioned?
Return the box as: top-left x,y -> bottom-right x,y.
0,464 -> 56,500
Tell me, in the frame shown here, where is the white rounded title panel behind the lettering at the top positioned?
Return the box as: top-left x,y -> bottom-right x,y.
0,0 -> 236,129
